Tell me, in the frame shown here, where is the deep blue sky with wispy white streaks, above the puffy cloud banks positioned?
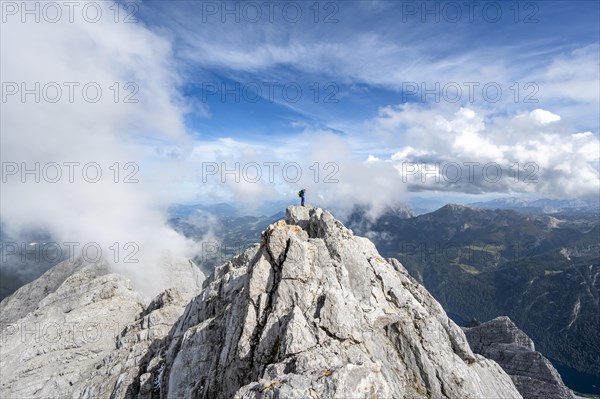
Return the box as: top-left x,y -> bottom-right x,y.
135,1 -> 600,140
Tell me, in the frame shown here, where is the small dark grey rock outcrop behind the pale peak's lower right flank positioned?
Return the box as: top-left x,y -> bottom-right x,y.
463,317 -> 574,399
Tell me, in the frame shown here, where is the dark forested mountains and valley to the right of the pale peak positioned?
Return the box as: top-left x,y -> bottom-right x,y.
347,205 -> 600,384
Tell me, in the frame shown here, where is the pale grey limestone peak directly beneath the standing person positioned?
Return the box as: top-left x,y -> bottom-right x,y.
148,207 -> 521,399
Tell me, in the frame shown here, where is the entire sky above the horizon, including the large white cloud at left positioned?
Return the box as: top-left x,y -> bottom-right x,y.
0,1 -> 600,242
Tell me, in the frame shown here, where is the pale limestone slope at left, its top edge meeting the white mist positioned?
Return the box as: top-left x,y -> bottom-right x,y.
0,258 -> 203,398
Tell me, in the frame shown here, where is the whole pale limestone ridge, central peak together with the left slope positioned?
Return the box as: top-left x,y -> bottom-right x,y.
0,206 -> 522,399
